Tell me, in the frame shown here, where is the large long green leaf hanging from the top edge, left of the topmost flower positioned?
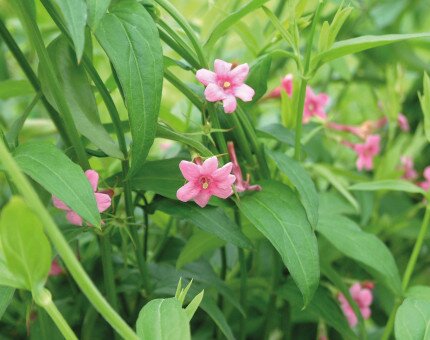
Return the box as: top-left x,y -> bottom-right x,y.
96,0 -> 163,176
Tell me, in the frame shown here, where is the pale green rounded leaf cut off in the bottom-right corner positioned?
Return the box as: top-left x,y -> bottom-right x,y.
394,298 -> 430,340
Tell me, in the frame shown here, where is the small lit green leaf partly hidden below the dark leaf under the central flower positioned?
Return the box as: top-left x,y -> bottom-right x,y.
176,230 -> 225,268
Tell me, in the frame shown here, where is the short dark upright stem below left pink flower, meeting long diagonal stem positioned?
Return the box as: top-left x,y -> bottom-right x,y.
99,232 -> 118,310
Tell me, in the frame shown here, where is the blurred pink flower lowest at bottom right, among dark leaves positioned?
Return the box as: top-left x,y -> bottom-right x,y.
338,283 -> 373,327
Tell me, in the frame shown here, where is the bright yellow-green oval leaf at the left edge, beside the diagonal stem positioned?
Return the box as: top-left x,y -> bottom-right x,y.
0,197 -> 51,290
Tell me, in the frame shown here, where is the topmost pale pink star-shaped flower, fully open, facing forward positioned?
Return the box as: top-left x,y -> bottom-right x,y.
196,59 -> 255,113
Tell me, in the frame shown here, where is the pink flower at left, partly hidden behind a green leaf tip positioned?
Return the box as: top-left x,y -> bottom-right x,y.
52,170 -> 111,226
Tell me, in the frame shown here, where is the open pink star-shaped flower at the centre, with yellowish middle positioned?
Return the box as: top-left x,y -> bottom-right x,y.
176,156 -> 236,208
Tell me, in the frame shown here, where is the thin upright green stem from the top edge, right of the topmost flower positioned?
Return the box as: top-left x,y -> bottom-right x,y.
294,0 -> 323,160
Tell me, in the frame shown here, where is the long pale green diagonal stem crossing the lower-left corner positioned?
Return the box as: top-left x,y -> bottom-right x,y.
0,140 -> 138,339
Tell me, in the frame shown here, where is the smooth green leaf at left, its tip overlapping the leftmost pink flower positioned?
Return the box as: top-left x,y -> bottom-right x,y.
14,142 -> 101,227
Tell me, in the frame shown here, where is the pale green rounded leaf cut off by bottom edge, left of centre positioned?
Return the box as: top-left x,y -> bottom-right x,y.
136,298 -> 191,340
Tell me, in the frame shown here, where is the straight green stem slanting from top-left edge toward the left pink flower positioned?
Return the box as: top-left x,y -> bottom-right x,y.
15,0 -> 90,169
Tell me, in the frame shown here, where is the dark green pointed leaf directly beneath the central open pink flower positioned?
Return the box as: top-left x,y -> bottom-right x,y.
156,200 -> 251,248
